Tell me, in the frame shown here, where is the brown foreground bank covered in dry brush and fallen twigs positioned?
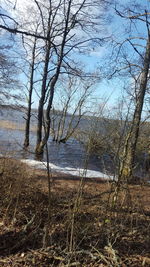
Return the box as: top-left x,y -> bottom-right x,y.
0,158 -> 150,267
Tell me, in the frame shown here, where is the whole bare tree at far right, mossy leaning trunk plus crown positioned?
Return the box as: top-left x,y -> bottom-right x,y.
109,3 -> 150,181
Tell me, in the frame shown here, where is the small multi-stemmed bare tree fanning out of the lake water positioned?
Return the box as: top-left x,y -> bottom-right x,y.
52,76 -> 96,143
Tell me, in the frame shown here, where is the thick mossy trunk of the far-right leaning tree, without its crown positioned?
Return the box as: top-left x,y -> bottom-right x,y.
119,36 -> 150,181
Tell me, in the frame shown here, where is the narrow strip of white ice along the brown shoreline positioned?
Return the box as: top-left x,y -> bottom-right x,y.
21,159 -> 114,180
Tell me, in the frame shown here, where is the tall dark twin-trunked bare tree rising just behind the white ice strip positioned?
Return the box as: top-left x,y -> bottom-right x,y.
35,0 -> 108,154
